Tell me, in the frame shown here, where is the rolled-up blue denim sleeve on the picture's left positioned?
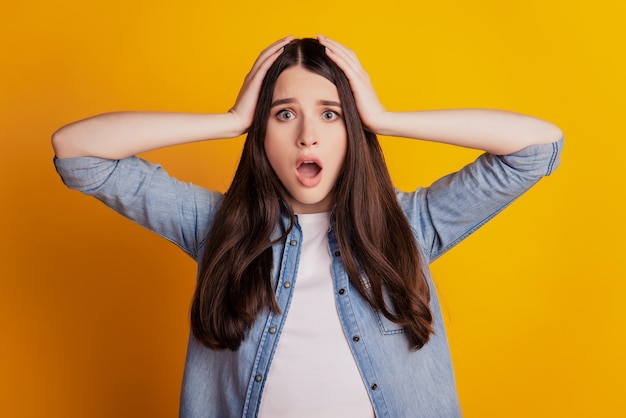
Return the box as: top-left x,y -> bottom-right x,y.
54,157 -> 222,259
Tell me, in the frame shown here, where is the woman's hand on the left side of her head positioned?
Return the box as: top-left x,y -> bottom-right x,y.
229,35 -> 293,133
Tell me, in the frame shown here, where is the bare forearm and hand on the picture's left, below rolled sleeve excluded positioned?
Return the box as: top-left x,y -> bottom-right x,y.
52,37 -> 291,159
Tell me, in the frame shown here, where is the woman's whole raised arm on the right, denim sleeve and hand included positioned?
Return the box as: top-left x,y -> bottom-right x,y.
319,37 -> 563,261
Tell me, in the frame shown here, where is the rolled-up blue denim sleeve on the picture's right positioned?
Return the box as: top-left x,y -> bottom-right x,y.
398,139 -> 563,261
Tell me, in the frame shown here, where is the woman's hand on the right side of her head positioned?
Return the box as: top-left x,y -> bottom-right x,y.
317,35 -> 387,133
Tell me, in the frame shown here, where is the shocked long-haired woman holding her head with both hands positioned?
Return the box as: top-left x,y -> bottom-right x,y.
53,36 -> 562,418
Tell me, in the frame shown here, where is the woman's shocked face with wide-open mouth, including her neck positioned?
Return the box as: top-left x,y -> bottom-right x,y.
265,67 -> 348,213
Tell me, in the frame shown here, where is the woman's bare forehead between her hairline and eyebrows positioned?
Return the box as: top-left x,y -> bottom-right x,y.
273,66 -> 339,101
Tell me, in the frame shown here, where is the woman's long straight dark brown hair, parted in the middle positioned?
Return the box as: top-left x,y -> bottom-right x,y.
191,39 -> 433,350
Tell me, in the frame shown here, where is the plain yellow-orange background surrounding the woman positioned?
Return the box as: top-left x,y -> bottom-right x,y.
0,0 -> 626,417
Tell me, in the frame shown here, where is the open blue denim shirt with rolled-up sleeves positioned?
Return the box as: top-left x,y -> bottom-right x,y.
55,140 -> 563,418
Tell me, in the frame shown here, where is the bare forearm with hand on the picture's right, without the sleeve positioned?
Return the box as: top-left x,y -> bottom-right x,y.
319,36 -> 563,155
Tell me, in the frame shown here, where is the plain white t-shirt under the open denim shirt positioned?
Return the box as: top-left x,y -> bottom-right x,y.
259,213 -> 374,418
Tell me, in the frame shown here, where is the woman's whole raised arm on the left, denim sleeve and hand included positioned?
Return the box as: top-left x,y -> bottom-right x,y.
53,38 -> 290,258
